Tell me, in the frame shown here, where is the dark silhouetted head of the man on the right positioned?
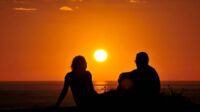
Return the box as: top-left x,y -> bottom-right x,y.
135,52 -> 149,69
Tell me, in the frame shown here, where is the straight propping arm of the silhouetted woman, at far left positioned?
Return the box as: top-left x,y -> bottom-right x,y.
56,76 -> 69,106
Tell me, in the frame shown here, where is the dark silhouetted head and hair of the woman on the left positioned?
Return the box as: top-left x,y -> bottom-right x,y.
71,55 -> 87,71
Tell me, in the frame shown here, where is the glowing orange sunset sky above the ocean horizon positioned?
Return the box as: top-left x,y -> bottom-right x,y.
0,0 -> 200,81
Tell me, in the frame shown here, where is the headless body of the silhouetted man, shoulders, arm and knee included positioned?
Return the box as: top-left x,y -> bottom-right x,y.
118,66 -> 160,96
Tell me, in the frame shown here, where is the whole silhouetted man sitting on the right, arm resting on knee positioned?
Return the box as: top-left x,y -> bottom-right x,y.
118,52 -> 160,97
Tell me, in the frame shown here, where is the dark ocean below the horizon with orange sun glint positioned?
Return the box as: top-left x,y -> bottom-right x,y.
0,81 -> 200,109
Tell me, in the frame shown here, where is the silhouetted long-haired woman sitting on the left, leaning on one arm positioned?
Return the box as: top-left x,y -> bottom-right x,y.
56,55 -> 97,107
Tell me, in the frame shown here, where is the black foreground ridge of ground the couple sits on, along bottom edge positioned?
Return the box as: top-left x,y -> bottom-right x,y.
0,91 -> 200,112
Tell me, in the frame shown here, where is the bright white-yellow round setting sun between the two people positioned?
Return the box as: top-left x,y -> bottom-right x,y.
94,49 -> 107,62
